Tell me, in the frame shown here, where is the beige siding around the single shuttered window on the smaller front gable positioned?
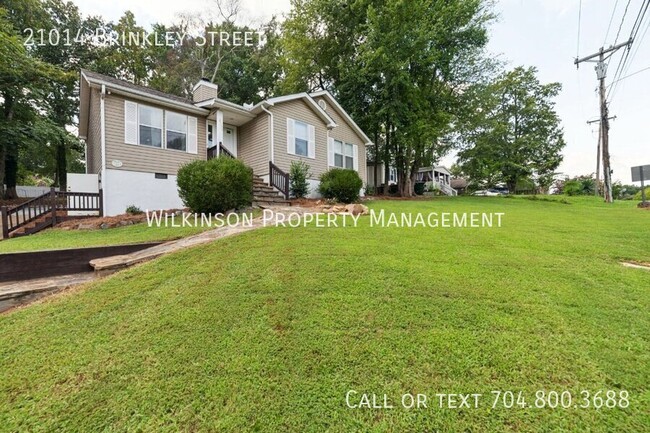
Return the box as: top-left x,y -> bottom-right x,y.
270,99 -> 328,179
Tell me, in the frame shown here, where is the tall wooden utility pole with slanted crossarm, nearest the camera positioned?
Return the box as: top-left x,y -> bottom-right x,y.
574,38 -> 634,203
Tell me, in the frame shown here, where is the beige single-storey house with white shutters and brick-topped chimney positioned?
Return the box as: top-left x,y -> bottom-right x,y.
79,70 -> 372,215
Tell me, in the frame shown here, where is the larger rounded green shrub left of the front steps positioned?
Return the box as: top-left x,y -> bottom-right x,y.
177,156 -> 253,214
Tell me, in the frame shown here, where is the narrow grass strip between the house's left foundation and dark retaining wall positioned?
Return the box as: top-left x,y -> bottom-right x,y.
0,211 -> 261,254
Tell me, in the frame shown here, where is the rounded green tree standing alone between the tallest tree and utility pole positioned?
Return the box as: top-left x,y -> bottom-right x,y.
458,67 -> 566,191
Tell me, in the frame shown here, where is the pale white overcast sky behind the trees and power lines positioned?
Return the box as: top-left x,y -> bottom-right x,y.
75,0 -> 650,183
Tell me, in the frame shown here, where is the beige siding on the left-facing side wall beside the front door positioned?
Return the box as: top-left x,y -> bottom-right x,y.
237,113 -> 271,176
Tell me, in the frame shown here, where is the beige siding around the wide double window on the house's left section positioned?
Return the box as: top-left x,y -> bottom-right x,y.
105,95 -> 207,175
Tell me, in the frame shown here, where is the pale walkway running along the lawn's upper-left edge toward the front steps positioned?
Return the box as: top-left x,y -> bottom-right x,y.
0,206 -> 313,312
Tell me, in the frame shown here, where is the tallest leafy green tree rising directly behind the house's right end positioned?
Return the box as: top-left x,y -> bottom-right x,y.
283,0 -> 492,195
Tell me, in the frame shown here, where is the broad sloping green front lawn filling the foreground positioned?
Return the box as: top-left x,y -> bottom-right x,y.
0,197 -> 650,432
